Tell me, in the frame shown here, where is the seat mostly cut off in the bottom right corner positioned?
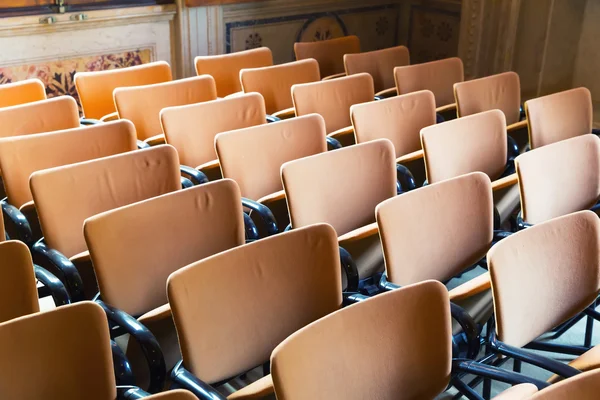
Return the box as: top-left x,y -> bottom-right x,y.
494,371 -> 600,400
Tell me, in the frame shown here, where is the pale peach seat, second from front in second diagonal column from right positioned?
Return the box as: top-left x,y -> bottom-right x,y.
421,110 -> 519,228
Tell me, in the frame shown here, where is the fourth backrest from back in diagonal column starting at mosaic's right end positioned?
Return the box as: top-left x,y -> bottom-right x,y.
215,114 -> 327,200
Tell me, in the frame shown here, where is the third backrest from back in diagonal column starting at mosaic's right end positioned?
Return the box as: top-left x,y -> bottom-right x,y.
160,93 -> 267,167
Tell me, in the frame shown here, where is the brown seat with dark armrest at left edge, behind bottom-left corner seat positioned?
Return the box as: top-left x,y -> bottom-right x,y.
0,240 -> 70,320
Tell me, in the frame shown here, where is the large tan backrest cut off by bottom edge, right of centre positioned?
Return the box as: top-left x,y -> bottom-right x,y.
271,281 -> 452,400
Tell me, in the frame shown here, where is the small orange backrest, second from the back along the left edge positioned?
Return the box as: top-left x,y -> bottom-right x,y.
0,96 -> 79,138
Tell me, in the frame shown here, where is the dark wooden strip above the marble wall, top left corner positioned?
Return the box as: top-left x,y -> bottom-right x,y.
0,0 -> 175,17
